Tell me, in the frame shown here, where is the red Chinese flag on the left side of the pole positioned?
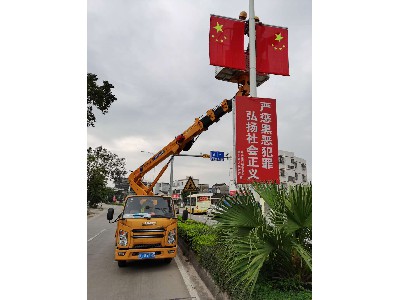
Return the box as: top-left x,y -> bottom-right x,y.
209,15 -> 246,70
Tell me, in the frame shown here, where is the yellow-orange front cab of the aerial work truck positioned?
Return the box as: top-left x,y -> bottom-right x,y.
107,195 -> 178,267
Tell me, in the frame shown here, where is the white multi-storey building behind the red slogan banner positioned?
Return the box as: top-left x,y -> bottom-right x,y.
279,150 -> 307,186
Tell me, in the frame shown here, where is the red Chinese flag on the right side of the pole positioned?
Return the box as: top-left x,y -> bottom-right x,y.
256,24 -> 289,76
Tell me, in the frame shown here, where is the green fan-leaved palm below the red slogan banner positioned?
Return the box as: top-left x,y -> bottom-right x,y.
214,183 -> 312,294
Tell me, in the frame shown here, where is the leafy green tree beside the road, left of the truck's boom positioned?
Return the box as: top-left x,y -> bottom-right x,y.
87,146 -> 127,207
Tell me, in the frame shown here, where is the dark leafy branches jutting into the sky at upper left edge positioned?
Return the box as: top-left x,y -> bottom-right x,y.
87,73 -> 117,127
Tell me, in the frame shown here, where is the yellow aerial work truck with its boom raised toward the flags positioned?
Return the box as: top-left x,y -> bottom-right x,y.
107,75 -> 249,267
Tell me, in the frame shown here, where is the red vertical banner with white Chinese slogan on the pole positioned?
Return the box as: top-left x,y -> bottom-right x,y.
235,96 -> 279,184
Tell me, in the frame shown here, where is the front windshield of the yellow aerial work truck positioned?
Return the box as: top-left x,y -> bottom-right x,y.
124,196 -> 173,218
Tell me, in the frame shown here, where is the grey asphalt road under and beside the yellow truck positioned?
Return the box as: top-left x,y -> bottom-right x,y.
87,206 -> 213,300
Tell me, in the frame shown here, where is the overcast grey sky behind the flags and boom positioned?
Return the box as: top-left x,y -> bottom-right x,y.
87,0 -> 312,186
